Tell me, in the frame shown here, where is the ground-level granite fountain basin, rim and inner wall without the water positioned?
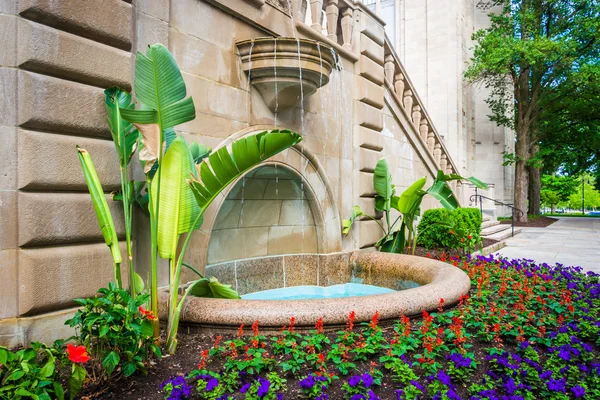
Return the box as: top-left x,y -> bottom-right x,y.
159,251 -> 471,333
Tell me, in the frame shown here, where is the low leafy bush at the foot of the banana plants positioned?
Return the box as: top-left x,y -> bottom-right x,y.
65,283 -> 161,383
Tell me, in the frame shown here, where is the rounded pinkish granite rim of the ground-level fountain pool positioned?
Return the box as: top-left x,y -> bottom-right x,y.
159,251 -> 471,332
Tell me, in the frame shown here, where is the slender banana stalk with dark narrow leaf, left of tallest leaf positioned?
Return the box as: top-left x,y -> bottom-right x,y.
104,87 -> 144,297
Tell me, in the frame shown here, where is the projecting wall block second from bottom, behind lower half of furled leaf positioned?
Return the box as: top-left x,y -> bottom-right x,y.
19,192 -> 125,246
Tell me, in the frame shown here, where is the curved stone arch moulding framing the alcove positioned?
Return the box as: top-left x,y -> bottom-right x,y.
191,125 -> 342,265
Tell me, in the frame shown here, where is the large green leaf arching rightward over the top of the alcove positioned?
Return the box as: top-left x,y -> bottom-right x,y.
190,130 -> 302,212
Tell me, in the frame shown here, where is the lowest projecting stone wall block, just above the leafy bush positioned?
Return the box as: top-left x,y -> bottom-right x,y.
18,243 -> 128,315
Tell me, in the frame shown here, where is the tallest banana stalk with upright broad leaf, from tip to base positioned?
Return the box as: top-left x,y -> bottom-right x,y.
119,44 -> 196,337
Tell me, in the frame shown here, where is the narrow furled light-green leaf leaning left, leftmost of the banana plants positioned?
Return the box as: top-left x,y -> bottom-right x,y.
77,146 -> 123,288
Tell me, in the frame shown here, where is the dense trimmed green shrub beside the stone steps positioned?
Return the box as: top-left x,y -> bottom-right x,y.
417,208 -> 481,249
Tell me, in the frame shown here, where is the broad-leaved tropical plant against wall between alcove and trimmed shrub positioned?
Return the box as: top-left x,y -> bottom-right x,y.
342,158 -> 487,254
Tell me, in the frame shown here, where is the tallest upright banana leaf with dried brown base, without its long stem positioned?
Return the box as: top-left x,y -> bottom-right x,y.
120,44 -> 196,173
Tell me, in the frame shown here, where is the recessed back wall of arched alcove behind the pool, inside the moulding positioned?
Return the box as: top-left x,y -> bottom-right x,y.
207,163 -> 322,264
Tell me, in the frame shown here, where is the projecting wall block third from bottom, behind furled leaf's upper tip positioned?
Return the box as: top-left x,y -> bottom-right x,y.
18,129 -> 120,192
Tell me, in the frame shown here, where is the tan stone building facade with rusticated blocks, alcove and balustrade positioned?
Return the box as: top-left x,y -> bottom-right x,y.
0,0 -> 500,346
